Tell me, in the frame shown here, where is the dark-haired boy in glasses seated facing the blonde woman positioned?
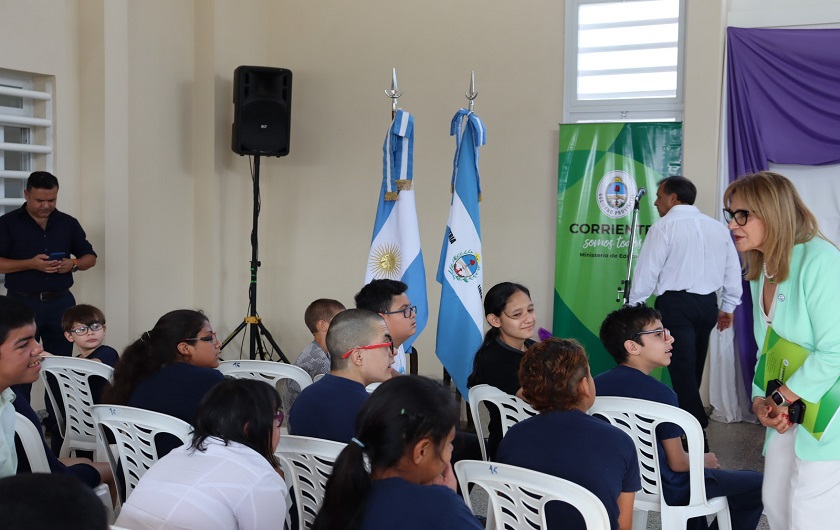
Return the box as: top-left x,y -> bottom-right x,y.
595,304 -> 763,530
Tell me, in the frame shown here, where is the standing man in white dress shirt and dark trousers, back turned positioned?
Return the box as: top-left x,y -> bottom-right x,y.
630,176 -> 741,444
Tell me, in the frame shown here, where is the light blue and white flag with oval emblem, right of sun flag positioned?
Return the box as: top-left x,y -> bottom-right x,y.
435,109 -> 487,398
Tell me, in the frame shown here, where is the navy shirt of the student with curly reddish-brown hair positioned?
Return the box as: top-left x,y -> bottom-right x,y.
497,410 -> 642,530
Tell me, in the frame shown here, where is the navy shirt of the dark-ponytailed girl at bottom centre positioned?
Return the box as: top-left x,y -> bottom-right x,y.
360,474 -> 484,530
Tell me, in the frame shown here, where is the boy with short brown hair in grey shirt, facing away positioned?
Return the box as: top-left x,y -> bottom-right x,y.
283,298 -> 346,413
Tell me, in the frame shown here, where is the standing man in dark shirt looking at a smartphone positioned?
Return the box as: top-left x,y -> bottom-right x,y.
0,171 -> 96,398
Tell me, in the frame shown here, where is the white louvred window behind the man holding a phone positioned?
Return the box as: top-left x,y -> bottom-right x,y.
0,69 -> 53,214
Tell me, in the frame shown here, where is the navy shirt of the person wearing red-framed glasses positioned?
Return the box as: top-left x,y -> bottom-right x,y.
289,374 -> 368,443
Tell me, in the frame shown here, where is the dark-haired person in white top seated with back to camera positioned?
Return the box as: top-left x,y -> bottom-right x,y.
116,379 -> 287,530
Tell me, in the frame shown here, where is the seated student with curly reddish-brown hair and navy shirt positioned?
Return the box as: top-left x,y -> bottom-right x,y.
496,338 -> 641,530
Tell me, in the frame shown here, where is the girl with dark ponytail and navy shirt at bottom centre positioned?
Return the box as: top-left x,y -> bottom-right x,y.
312,376 -> 482,530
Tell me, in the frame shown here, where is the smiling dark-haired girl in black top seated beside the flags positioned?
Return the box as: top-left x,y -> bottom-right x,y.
467,282 -> 537,459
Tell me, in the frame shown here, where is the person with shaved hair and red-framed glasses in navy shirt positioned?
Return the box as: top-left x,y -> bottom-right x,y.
289,309 -> 394,443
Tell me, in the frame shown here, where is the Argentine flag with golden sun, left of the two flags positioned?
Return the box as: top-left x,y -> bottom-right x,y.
365,109 -> 429,374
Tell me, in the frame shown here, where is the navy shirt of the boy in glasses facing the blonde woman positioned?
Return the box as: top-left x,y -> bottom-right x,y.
595,364 -> 691,505
